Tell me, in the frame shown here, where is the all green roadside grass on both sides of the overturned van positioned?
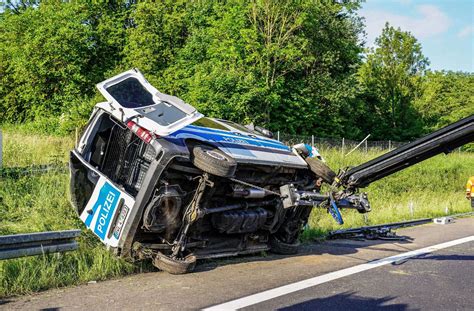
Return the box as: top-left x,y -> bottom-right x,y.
0,128 -> 474,297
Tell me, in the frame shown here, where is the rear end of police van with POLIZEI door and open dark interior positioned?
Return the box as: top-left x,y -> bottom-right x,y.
70,109 -> 156,247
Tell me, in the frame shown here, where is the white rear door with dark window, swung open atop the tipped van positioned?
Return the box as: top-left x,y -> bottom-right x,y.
97,69 -> 202,136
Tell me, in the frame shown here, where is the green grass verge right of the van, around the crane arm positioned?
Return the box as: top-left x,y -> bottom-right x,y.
304,149 -> 474,238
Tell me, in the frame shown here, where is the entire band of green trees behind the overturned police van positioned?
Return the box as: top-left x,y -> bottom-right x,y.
0,0 -> 473,140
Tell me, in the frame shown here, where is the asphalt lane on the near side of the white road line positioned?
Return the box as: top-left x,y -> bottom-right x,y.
244,242 -> 474,311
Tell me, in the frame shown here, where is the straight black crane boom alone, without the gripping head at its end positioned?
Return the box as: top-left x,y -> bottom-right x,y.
336,115 -> 474,189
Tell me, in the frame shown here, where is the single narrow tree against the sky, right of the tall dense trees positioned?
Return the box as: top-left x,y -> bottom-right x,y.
358,23 -> 429,141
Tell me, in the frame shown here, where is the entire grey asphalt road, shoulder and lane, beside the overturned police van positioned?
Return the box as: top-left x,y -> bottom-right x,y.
0,217 -> 474,310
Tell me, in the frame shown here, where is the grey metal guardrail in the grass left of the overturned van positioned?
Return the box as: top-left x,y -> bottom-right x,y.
0,230 -> 81,260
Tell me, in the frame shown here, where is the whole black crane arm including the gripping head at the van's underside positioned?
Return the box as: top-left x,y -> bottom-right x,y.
280,115 -> 474,224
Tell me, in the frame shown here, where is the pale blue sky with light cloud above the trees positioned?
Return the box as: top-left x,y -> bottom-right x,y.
359,0 -> 474,72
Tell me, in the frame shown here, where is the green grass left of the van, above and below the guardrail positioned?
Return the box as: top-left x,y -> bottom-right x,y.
0,131 -> 142,297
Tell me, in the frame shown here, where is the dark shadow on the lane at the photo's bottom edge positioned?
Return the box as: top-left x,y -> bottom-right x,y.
278,292 -> 409,311
